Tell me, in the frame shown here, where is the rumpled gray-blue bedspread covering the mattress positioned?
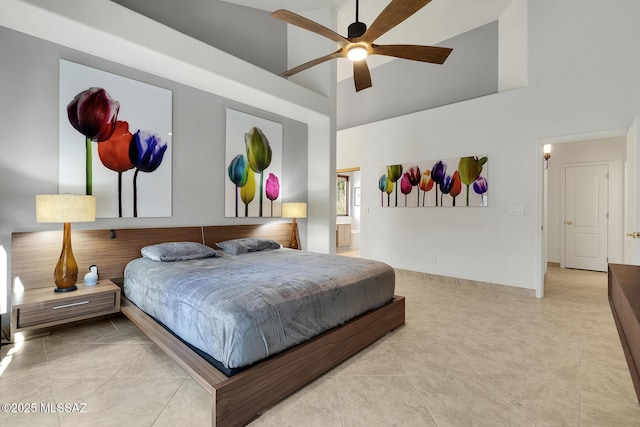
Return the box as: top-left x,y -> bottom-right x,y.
124,249 -> 395,368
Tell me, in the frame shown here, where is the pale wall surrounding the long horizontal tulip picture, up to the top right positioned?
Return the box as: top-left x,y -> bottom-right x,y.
338,0 -> 640,296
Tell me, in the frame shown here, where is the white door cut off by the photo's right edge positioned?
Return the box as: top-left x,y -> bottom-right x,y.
624,117 -> 640,265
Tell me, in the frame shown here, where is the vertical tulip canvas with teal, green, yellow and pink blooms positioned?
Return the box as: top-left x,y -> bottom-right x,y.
225,109 -> 282,217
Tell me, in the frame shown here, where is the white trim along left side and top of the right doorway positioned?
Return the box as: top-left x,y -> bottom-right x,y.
535,129 -> 633,298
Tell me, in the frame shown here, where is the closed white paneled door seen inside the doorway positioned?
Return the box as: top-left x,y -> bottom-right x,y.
564,164 -> 609,271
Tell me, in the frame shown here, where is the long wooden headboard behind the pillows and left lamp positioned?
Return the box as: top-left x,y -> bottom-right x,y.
11,222 -> 291,289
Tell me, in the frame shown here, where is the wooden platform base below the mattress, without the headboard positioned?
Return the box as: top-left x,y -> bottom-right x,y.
121,296 -> 405,427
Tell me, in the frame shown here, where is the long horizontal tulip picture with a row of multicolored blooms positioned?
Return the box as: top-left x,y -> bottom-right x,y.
378,156 -> 489,207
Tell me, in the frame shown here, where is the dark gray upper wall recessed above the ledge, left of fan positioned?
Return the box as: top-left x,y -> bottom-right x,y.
112,0 -> 287,74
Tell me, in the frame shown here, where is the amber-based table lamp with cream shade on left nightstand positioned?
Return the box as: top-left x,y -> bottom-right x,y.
36,194 -> 96,292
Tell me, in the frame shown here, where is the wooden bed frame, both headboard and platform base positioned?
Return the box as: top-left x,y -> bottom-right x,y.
11,226 -> 405,426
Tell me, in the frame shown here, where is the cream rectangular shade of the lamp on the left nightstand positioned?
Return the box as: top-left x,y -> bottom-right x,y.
36,194 -> 96,223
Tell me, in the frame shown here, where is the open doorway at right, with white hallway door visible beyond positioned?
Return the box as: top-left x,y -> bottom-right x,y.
536,130 -> 627,298
